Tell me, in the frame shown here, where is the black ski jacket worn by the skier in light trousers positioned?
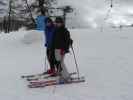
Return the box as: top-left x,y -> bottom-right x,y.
52,26 -> 72,52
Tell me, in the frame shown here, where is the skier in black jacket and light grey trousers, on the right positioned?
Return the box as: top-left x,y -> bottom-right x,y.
52,17 -> 72,81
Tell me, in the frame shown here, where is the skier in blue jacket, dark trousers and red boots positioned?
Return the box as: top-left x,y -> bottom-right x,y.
45,17 -> 56,75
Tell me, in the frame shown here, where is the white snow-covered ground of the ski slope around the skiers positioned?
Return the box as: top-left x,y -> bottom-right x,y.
0,28 -> 133,100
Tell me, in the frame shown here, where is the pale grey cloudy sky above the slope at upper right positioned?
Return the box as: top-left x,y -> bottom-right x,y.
58,0 -> 133,27
